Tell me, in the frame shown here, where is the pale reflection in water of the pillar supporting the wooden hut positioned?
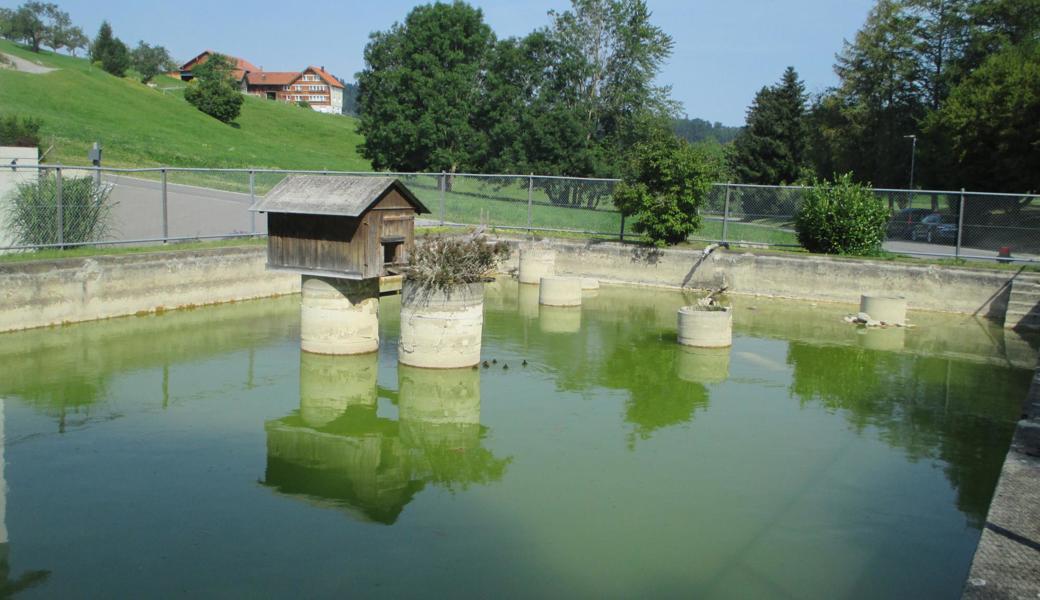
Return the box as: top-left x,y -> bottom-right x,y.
300,353 -> 380,427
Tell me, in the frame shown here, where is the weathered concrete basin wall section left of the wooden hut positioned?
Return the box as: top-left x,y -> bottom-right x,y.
0,246 -> 300,332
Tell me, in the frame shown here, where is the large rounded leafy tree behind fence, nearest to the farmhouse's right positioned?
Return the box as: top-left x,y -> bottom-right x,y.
358,1 -> 495,173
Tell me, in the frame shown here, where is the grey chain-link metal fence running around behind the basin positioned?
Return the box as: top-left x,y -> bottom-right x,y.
0,164 -> 1040,261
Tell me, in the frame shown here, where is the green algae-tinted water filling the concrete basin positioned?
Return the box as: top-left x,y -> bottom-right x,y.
0,281 -> 1035,599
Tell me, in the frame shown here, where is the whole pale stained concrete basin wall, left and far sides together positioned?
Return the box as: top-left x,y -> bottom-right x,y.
0,237 -> 1017,332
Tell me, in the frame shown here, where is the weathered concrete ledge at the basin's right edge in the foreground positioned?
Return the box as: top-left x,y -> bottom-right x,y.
964,369 -> 1040,600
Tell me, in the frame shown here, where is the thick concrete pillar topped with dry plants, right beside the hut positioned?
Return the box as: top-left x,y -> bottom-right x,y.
397,280 -> 484,369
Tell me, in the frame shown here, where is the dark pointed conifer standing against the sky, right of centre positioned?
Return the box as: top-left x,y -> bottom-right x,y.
732,67 -> 809,185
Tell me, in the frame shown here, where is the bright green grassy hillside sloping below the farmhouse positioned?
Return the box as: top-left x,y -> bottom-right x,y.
0,40 -> 371,171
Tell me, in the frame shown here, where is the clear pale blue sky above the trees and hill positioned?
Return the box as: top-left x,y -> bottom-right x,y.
8,0 -> 874,125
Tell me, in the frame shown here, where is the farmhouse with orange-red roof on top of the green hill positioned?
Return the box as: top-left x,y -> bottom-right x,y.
176,50 -> 343,114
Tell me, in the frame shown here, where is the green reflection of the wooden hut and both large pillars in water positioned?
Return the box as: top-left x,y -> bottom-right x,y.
260,353 -> 510,524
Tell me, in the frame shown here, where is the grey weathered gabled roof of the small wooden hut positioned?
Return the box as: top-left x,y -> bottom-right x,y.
250,175 -> 430,216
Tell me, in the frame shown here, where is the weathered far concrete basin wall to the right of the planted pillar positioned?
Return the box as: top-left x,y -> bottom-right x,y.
492,240 -> 1017,323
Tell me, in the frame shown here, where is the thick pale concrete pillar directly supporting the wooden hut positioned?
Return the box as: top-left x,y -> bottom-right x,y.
300,275 -> 380,355
